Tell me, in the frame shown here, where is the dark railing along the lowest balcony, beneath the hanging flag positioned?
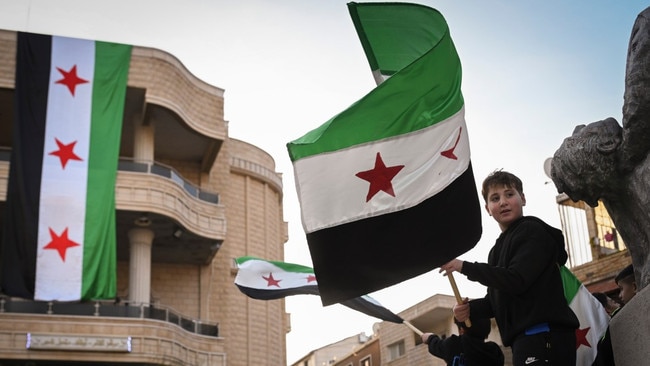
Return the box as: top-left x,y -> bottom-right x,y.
0,297 -> 219,337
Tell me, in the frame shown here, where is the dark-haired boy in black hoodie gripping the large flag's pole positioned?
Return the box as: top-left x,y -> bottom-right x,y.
440,170 -> 579,366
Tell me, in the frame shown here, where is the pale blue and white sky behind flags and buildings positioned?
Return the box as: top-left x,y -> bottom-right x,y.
0,0 -> 648,363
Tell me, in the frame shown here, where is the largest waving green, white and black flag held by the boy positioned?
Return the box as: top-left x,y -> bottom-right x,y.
287,3 -> 482,305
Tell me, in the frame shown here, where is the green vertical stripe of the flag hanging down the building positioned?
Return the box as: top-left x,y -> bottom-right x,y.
81,42 -> 131,299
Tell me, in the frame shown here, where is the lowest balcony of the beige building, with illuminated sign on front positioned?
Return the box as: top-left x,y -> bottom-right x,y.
0,298 -> 225,365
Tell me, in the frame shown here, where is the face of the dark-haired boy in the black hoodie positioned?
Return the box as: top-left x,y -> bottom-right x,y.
485,185 -> 526,231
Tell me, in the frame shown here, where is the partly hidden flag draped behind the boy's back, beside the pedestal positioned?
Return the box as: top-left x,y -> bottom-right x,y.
560,266 -> 610,366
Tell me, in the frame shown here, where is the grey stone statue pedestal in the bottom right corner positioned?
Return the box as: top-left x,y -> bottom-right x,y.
609,286 -> 650,366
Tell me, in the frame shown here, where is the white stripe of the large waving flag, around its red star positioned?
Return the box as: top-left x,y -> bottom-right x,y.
294,108 -> 470,233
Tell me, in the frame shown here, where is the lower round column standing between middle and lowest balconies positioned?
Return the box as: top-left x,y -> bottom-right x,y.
129,227 -> 154,305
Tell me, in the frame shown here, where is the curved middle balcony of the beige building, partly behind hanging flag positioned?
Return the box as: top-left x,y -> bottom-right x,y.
0,150 -> 226,265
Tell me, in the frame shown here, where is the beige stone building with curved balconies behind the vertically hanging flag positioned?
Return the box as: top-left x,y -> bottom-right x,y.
0,31 -> 290,366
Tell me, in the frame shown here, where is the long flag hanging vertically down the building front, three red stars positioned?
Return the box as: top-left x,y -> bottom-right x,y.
1,33 -> 131,301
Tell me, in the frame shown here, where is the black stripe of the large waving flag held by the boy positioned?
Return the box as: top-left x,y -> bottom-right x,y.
307,164 -> 482,305
